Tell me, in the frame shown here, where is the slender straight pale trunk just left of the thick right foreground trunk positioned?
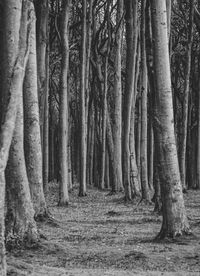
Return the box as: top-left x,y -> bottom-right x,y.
140,0 -> 150,201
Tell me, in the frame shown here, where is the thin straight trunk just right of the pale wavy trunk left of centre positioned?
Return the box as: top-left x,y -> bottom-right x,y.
79,0 -> 87,196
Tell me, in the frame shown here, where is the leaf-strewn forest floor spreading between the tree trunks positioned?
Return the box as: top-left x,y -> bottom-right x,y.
7,184 -> 200,276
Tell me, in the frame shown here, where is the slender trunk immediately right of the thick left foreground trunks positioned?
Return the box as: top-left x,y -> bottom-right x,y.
35,0 -> 49,190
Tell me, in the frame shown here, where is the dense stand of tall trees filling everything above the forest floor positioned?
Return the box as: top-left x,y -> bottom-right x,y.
0,0 -> 200,275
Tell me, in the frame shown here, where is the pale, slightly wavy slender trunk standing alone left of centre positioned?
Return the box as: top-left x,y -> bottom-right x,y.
59,0 -> 71,205
